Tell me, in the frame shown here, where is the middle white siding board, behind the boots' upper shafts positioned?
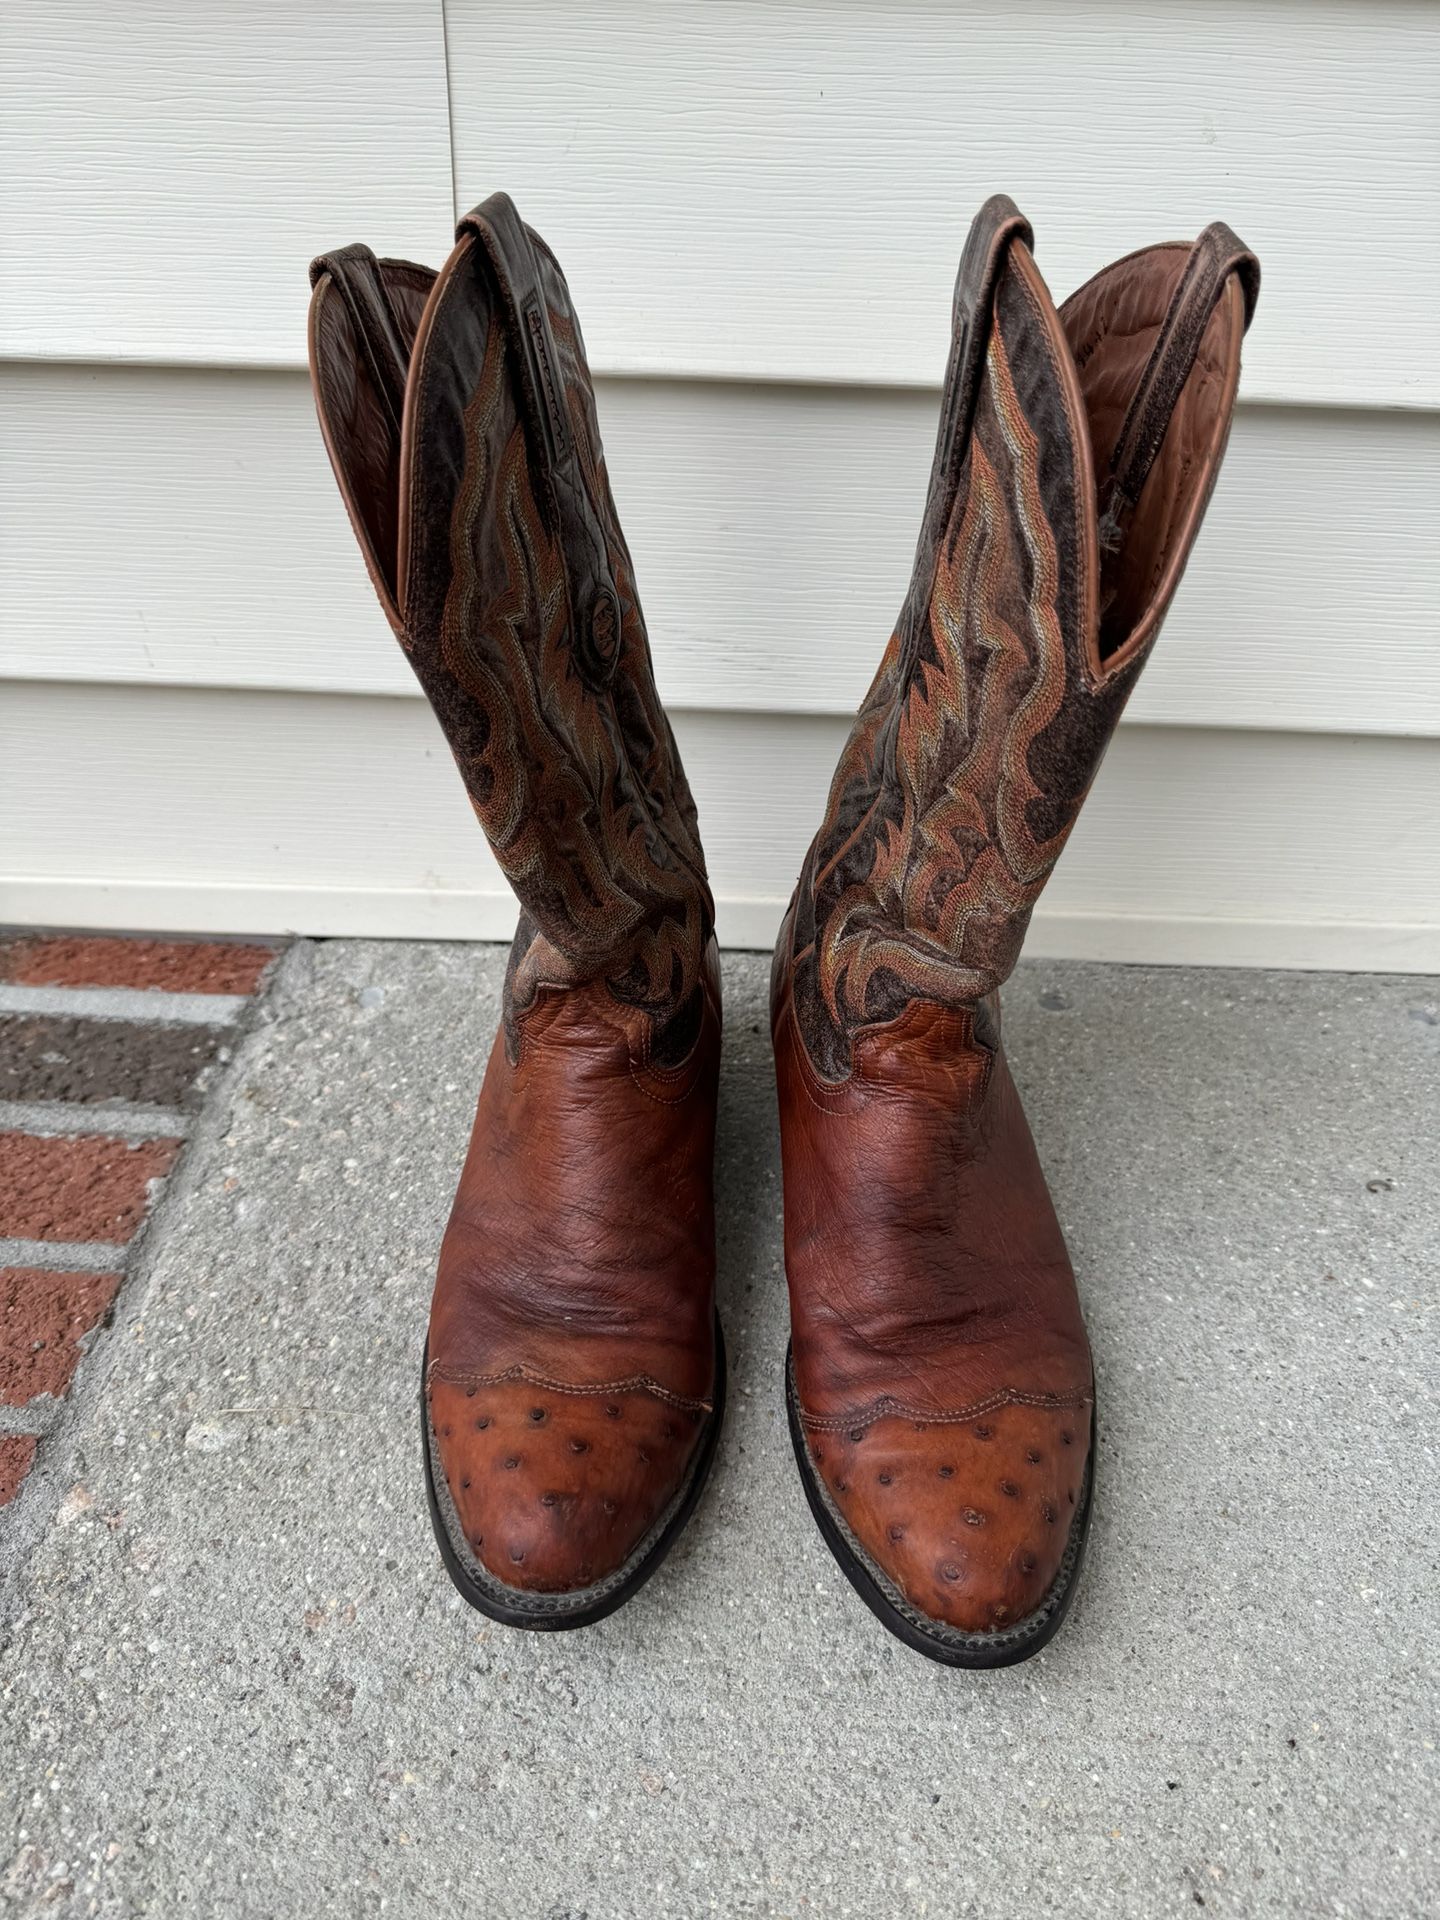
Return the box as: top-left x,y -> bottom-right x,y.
0,367 -> 1440,733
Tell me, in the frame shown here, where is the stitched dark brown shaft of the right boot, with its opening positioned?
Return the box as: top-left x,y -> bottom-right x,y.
776,196 -> 1258,1079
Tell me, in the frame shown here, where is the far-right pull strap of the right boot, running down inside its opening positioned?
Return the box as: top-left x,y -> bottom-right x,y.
1100,221 -> 1260,547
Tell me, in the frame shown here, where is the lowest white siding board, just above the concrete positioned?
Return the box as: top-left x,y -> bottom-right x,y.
0,684 -> 1440,968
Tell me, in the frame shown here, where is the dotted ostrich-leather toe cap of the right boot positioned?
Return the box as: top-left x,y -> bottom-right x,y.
806,1404 -> 1091,1634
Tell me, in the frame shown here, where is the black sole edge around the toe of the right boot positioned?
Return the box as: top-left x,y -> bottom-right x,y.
785,1348 -> 1096,1670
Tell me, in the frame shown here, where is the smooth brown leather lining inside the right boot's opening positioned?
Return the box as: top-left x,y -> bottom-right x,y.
1060,246 -> 1244,660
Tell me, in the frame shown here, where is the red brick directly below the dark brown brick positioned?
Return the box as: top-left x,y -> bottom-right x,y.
0,1133 -> 180,1244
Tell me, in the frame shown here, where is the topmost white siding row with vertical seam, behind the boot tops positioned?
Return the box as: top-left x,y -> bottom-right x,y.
0,0 -> 1440,407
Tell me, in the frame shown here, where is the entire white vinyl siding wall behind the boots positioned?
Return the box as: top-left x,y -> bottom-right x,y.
0,0 -> 1440,968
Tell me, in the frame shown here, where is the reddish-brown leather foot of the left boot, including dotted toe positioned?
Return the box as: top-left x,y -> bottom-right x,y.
428,950 -> 720,1592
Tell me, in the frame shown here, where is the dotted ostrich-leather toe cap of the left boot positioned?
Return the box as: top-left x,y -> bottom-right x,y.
430,1382 -> 705,1594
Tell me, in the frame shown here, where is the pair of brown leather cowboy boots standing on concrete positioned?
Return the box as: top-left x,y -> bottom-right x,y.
311,194 -> 1260,1667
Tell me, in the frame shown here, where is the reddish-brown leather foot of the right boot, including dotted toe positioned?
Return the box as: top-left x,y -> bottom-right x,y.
774,960 -> 1092,1632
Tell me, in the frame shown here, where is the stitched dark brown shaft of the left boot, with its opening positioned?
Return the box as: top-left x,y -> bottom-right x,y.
309,194 -> 714,1060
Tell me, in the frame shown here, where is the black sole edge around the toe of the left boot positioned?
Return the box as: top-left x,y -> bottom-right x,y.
420,1313 -> 728,1634
